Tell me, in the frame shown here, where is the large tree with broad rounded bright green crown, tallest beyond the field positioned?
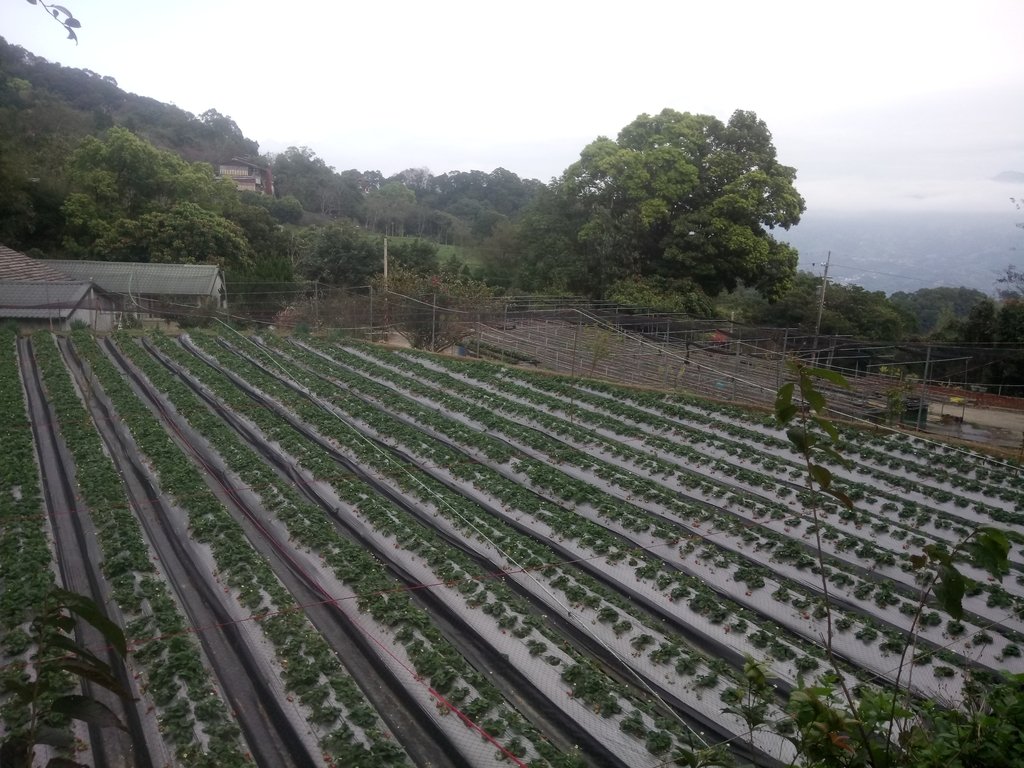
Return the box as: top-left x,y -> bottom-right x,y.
527,110 -> 804,299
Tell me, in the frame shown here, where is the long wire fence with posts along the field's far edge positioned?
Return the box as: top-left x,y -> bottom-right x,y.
81,283 -> 1024,418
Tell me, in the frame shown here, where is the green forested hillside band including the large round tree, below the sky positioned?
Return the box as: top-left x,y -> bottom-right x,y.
0,33 -> 1021,364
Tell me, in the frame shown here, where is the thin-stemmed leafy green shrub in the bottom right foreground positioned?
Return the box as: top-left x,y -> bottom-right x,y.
770,362 -> 1024,768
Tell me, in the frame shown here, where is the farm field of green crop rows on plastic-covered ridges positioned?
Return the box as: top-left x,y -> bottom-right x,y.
0,331 -> 1024,768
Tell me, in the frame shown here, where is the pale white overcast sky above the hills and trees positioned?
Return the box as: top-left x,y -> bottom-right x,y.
0,0 -> 1024,213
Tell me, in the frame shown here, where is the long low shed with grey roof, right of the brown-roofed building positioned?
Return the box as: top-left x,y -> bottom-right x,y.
45,259 -> 227,319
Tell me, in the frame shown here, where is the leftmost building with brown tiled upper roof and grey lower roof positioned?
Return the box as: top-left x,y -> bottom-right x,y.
0,246 -> 116,331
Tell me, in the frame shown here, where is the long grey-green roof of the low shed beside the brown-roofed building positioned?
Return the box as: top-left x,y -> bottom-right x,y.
47,259 -> 220,296
